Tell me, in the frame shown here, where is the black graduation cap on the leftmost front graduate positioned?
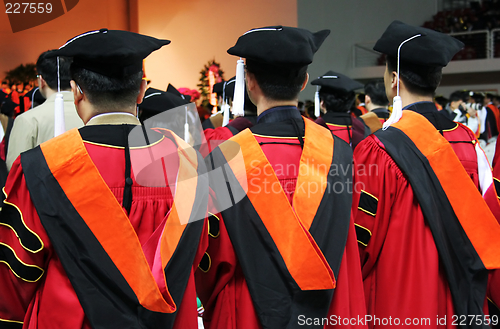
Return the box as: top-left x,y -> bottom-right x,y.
51,29 -> 170,78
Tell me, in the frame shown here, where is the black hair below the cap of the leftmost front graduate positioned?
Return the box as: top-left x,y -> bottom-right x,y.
71,64 -> 143,112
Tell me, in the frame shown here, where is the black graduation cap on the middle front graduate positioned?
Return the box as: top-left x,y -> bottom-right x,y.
227,26 -> 330,67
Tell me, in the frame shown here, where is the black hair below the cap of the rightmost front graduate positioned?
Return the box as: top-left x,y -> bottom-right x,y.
387,56 -> 443,96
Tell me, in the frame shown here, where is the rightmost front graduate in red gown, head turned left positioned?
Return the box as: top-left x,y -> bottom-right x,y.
353,21 -> 500,328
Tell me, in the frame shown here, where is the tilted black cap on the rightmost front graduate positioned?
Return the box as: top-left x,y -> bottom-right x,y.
373,21 -> 464,67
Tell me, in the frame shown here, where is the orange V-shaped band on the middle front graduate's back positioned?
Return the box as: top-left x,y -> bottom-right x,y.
219,120 -> 335,290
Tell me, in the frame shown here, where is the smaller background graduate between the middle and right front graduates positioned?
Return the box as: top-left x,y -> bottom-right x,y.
311,71 -> 370,148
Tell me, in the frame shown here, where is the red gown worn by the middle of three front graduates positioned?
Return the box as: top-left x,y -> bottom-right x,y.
196,106 -> 365,329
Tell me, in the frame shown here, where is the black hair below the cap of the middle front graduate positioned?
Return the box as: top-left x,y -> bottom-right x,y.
246,58 -> 307,101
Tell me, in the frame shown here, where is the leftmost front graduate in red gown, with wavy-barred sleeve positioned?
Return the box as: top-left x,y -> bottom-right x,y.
0,29 -> 208,329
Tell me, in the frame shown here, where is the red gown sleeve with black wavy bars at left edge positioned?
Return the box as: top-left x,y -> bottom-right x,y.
0,158 -> 52,328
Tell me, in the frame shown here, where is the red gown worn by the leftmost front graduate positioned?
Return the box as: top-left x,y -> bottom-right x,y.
0,121 -> 206,329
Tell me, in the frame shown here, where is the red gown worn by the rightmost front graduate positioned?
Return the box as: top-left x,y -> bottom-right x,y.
354,106 -> 500,328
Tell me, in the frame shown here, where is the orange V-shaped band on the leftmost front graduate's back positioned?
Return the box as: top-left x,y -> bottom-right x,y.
40,128 -> 201,313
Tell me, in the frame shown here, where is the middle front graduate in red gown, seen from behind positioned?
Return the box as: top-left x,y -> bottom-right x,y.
196,26 -> 365,329
